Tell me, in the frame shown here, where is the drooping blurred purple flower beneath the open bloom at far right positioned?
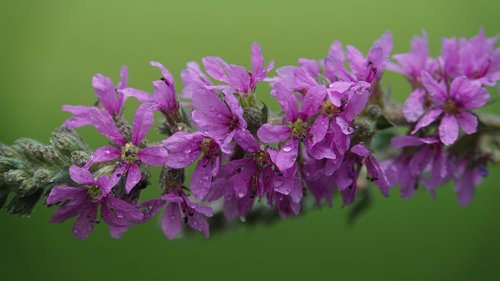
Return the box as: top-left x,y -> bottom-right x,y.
386,136 -> 449,198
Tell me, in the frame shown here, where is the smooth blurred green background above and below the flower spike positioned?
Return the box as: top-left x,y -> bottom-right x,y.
0,0 -> 500,280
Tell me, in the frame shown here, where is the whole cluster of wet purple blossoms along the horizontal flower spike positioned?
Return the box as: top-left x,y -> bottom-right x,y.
40,31 -> 500,239
